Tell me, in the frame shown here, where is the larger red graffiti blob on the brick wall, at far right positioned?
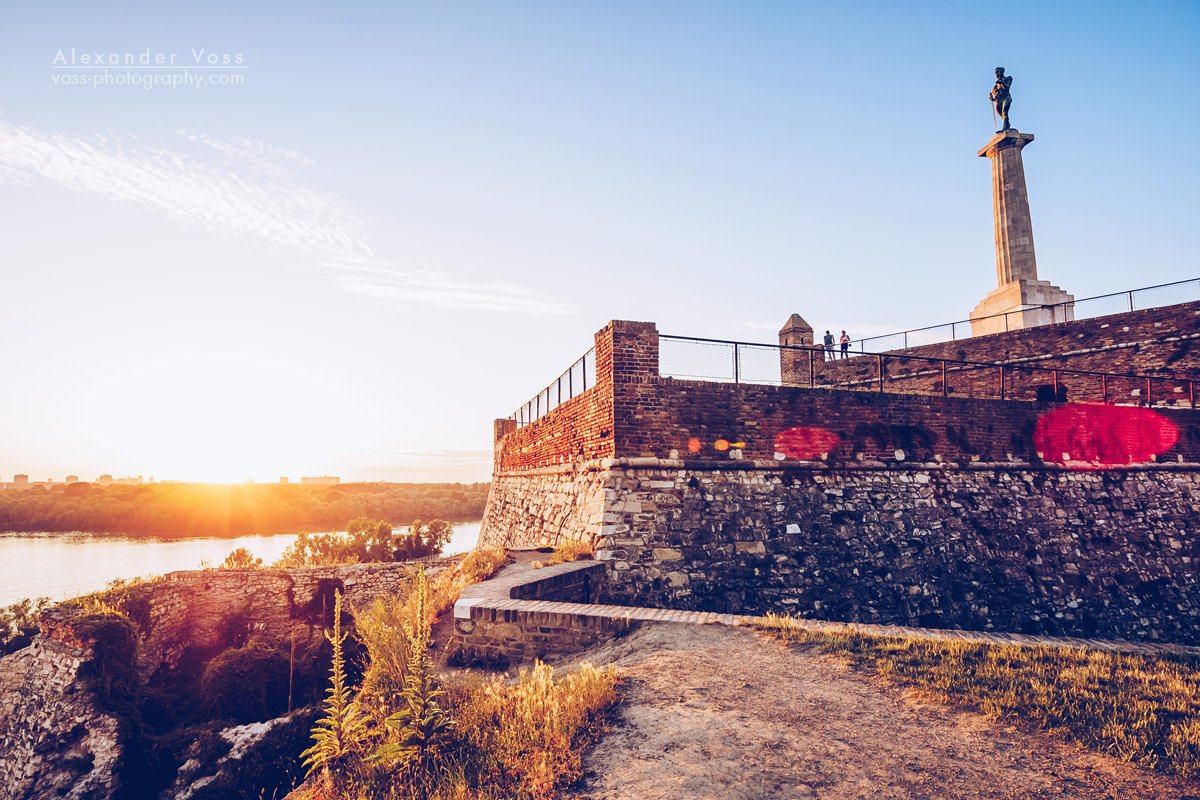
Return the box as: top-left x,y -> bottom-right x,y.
1033,403 -> 1180,469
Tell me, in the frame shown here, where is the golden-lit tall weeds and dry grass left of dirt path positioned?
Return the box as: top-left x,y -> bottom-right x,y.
297,549 -> 618,800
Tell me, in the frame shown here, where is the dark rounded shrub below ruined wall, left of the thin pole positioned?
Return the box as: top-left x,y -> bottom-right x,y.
200,639 -> 288,723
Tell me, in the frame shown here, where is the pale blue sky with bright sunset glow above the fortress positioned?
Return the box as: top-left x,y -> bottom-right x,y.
0,0 -> 1200,481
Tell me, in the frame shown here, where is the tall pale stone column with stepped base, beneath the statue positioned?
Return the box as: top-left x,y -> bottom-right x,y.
971,130 -> 1075,336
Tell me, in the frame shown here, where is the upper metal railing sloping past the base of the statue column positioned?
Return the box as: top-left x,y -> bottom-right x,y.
851,278 -> 1200,353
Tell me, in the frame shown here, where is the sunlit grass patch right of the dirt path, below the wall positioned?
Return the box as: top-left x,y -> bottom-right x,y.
752,616 -> 1200,778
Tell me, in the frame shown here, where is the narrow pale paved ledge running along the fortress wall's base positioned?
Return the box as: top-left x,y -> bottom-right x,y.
455,553 -> 1200,655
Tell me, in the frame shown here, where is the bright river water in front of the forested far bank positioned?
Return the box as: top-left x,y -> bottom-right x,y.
0,522 -> 480,607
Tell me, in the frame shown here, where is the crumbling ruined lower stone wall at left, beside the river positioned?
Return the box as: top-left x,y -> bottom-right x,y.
0,564 -> 410,800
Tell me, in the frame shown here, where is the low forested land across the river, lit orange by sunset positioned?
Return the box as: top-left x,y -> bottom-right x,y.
0,483 -> 490,536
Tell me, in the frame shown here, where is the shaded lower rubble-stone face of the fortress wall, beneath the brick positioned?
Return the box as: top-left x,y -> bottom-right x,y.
596,459 -> 1200,644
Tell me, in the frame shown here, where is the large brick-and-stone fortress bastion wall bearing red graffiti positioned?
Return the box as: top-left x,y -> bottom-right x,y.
480,303 -> 1200,644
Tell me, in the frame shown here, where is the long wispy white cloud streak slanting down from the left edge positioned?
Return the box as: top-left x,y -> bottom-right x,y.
0,120 -> 571,314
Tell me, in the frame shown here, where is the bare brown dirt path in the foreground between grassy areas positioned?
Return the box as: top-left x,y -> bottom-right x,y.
569,625 -> 1200,800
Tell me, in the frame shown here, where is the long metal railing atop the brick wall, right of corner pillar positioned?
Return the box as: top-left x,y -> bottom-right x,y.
659,335 -> 1200,408
